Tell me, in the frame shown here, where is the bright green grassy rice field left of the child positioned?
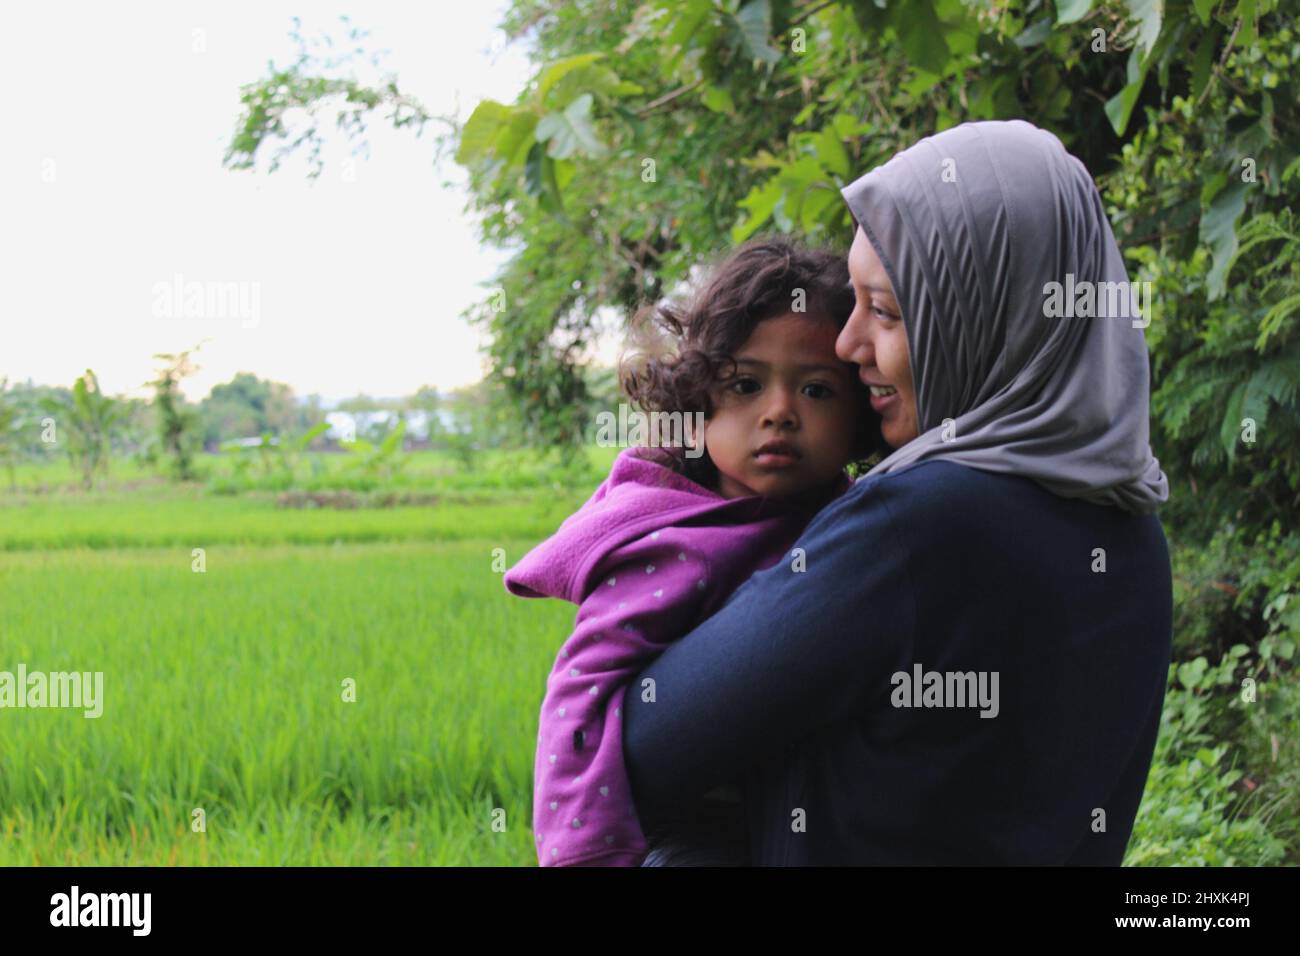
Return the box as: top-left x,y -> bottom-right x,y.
0,450 -> 605,865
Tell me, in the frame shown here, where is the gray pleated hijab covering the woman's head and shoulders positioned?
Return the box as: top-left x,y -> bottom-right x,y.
842,120 -> 1169,512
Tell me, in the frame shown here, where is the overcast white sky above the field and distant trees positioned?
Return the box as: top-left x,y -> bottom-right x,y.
0,0 -> 613,401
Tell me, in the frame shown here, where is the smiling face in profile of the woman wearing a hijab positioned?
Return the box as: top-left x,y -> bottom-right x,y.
835,229 -> 919,447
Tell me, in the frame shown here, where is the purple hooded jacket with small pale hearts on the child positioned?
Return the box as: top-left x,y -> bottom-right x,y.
506,447 -> 852,866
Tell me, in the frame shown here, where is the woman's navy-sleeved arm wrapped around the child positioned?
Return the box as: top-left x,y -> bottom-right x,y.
623,479 -> 915,819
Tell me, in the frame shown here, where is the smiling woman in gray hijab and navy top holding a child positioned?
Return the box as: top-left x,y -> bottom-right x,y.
623,121 -> 1173,865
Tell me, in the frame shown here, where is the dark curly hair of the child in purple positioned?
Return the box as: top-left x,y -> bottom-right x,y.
619,237 -> 887,489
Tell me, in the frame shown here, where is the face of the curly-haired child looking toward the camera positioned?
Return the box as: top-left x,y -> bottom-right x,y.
705,312 -> 866,498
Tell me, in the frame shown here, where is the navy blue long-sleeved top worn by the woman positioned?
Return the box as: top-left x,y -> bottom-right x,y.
623,462 -> 1173,865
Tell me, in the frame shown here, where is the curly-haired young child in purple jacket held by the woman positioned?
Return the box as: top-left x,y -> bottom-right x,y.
506,239 -> 881,866
